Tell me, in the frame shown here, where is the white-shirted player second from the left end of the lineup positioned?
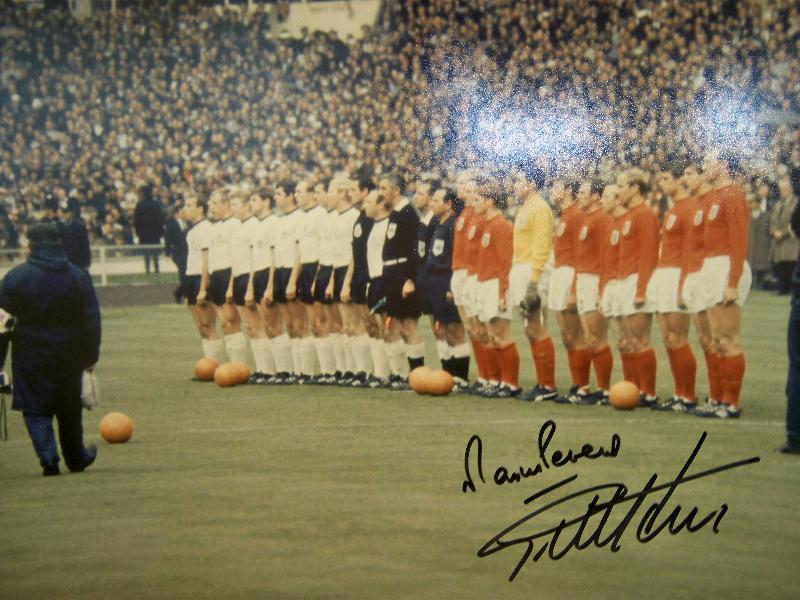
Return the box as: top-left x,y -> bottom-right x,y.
197,188 -> 247,362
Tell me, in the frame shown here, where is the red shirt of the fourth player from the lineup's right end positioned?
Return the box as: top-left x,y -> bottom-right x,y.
619,204 -> 658,298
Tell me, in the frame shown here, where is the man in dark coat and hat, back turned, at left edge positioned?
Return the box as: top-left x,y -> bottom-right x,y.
0,223 -> 100,475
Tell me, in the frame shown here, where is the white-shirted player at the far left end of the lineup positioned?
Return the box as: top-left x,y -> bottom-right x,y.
182,191 -> 225,363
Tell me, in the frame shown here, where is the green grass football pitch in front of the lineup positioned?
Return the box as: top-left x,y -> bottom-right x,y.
0,293 -> 800,599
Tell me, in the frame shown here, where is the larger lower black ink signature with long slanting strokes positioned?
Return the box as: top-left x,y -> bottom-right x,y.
478,432 -> 760,581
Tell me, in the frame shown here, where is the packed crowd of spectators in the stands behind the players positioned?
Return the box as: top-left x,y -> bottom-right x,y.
0,0 -> 800,280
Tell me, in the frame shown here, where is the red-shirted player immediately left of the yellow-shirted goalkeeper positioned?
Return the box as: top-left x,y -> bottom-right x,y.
476,176 -> 520,398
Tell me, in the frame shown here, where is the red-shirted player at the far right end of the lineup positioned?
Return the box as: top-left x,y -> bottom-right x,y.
694,156 -> 752,419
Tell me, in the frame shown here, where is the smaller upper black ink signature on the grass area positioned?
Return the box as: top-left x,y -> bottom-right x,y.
461,420 -> 622,494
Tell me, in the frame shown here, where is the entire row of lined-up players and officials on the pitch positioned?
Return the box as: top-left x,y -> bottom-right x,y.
175,156 -> 750,418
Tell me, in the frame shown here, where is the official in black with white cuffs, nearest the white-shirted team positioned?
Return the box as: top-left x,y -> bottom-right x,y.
379,175 -> 425,370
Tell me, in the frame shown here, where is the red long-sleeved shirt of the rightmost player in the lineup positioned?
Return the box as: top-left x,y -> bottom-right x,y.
703,184 -> 750,288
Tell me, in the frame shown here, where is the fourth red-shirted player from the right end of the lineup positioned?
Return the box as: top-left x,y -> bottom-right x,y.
618,170 -> 659,407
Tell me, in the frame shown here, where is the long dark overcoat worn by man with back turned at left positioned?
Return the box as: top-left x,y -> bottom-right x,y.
0,251 -> 100,415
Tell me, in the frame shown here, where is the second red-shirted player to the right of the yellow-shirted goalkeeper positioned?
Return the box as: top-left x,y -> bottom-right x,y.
575,179 -> 614,404
